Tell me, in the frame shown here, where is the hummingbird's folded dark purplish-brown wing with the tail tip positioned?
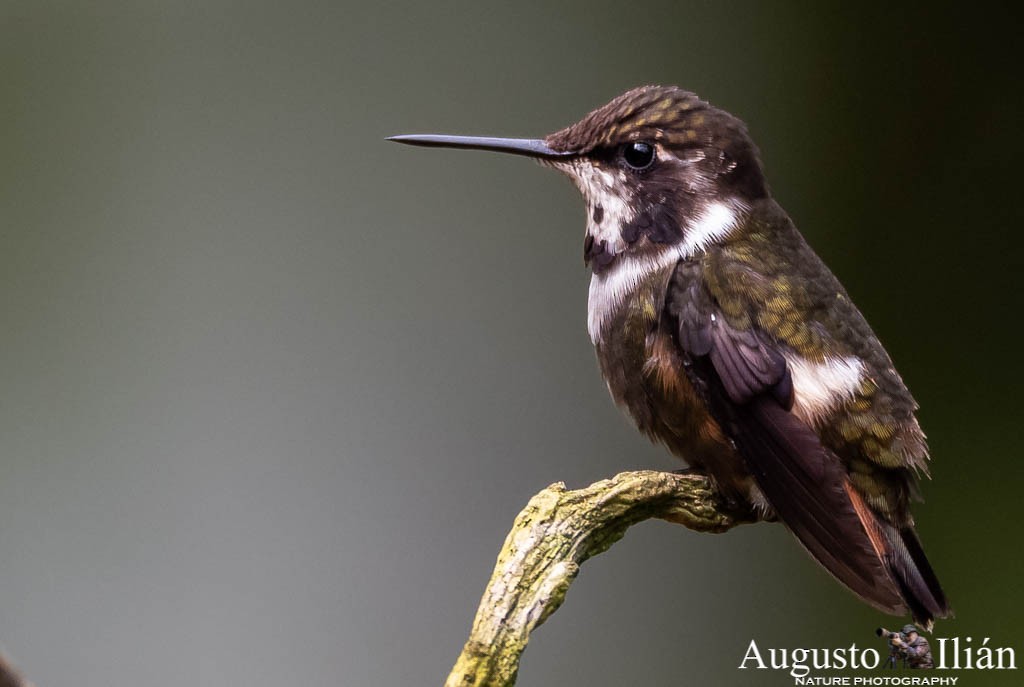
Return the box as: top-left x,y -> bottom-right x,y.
666,262 -> 947,626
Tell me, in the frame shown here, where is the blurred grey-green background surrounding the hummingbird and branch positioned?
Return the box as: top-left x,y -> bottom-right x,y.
0,0 -> 1024,687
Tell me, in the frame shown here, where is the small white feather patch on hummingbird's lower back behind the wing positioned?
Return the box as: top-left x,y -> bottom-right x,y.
785,355 -> 864,427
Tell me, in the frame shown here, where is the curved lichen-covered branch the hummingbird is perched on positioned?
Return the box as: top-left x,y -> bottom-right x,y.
445,470 -> 753,687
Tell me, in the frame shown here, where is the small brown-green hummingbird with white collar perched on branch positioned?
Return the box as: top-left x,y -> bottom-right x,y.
389,86 -> 950,629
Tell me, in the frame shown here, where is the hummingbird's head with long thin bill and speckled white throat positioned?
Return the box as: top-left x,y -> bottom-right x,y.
391,86 -> 768,273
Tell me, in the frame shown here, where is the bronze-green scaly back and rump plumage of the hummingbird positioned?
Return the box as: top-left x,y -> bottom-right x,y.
705,202 -> 928,509
